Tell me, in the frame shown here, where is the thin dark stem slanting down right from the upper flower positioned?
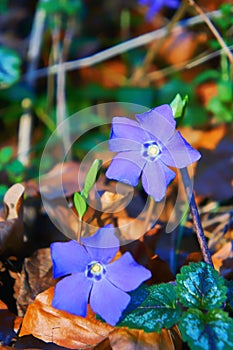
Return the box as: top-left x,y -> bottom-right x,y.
180,168 -> 213,266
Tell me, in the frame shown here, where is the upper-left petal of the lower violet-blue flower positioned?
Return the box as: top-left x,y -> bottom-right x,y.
50,241 -> 90,278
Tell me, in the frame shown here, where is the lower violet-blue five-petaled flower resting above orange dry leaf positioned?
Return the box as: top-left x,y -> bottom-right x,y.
51,225 -> 151,325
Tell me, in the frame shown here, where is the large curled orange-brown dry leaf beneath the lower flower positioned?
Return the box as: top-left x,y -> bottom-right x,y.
20,287 -> 113,349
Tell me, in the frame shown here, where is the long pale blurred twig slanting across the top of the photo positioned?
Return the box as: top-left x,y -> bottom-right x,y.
26,11 -> 221,79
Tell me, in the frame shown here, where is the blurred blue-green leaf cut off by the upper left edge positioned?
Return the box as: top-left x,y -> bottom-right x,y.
0,47 -> 21,88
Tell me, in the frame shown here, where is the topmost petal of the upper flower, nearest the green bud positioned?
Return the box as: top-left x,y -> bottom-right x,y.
136,105 -> 176,145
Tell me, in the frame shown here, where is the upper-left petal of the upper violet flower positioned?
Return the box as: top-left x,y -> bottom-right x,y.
110,117 -> 148,144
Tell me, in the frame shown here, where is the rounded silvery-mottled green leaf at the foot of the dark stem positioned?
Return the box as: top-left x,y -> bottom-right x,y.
176,262 -> 227,310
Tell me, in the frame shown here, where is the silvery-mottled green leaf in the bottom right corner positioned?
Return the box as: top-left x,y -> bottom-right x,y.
179,309 -> 233,350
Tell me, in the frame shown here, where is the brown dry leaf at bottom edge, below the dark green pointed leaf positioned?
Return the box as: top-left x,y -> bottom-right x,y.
109,328 -> 181,350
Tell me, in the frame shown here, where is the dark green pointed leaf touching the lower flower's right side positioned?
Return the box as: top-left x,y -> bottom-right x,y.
119,283 -> 181,332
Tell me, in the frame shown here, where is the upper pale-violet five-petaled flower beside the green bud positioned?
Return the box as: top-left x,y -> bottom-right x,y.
106,105 -> 201,201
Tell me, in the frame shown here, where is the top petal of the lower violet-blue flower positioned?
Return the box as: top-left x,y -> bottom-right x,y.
81,225 -> 119,264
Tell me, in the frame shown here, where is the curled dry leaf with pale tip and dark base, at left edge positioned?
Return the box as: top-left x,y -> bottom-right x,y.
0,184 -> 24,258
